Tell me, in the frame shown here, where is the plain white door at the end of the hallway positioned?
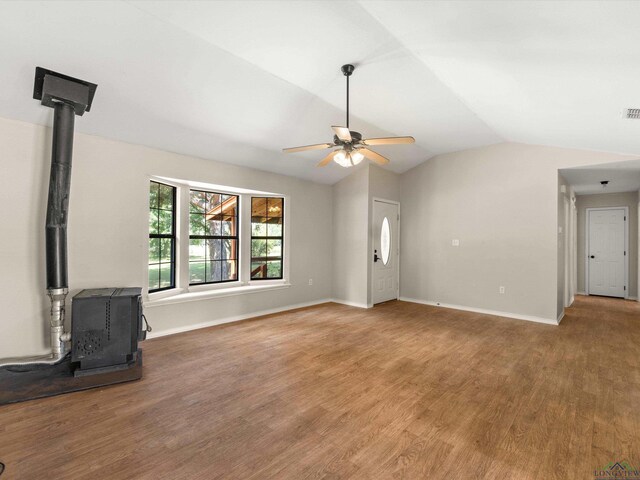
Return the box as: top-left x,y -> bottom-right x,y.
587,208 -> 626,297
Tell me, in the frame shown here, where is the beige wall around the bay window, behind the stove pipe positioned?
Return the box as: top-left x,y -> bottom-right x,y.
0,119 -> 333,357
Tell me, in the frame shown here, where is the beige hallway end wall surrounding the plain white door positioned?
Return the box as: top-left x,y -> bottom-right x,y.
576,192 -> 638,298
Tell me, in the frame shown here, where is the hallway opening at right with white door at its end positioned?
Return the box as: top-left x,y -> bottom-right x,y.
558,163 -> 640,318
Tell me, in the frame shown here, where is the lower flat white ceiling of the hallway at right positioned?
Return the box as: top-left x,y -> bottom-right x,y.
560,160 -> 640,195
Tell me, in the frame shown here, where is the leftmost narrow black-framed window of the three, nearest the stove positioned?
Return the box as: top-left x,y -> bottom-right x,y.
149,181 -> 176,292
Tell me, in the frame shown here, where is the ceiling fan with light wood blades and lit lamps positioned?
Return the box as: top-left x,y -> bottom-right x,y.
282,65 -> 415,167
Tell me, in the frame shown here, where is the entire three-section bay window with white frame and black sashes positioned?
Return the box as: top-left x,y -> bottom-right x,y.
148,177 -> 291,294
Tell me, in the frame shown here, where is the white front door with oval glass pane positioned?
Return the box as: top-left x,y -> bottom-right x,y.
372,200 -> 400,304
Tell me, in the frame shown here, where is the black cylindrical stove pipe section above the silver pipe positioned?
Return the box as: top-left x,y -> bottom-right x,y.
46,102 -> 76,290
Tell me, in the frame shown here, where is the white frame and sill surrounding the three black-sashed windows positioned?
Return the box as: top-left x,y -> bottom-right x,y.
143,176 -> 291,304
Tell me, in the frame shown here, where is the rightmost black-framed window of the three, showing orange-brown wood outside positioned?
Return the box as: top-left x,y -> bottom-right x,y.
251,197 -> 284,280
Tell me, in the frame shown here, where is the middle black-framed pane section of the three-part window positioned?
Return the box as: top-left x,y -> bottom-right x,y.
189,190 -> 239,285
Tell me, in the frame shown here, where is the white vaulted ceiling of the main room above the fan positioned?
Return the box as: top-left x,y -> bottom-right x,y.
0,1 -> 640,183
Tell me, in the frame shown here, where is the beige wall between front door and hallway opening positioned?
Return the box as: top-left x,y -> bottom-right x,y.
400,143 -> 635,322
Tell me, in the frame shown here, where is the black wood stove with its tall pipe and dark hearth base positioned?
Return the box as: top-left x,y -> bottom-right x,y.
0,67 -> 145,405
